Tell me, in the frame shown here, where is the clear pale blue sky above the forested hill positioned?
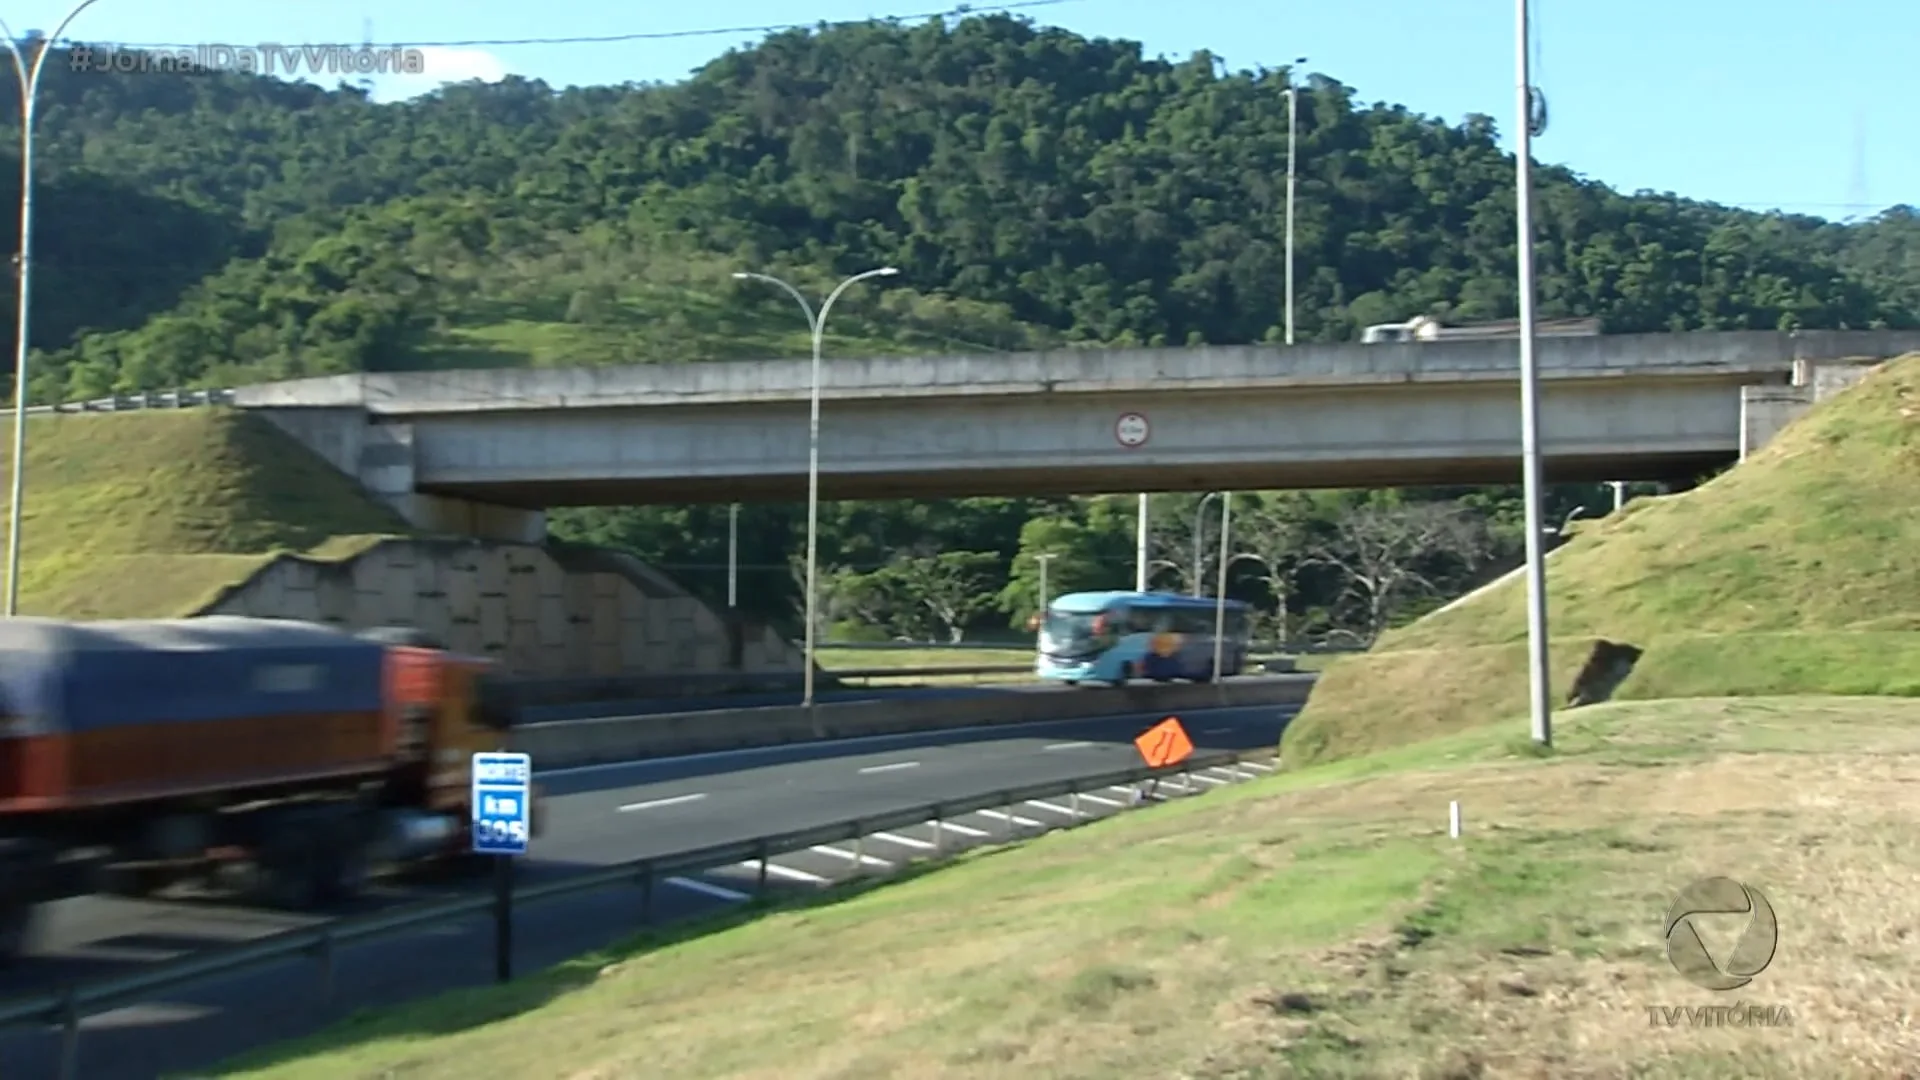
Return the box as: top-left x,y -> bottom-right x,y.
11,0 -> 1920,219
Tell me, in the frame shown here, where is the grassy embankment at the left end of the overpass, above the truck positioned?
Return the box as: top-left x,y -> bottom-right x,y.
0,409 -> 407,619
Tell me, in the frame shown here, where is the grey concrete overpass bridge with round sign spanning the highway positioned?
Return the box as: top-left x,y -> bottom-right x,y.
234,331 -> 1920,540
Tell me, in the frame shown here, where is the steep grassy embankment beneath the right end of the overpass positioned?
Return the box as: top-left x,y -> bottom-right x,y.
1283,356 -> 1920,763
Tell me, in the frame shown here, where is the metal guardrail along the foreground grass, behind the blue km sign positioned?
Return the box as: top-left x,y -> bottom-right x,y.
0,749 -> 1271,1080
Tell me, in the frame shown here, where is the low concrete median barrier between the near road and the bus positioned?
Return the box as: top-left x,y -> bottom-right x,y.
513,675 -> 1313,769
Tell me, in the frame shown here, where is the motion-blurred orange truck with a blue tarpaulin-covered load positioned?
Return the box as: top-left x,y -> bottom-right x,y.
0,617 -> 543,961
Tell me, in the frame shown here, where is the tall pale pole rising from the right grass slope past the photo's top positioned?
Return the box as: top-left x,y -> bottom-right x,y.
1513,0 -> 1553,746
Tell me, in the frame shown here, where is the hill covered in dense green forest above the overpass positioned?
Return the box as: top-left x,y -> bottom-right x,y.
0,15 -> 1920,396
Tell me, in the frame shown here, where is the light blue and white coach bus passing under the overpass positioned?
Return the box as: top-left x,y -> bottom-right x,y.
1033,592 -> 1248,686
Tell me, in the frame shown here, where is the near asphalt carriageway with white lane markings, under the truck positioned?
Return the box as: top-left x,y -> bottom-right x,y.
0,705 -> 1294,1080
